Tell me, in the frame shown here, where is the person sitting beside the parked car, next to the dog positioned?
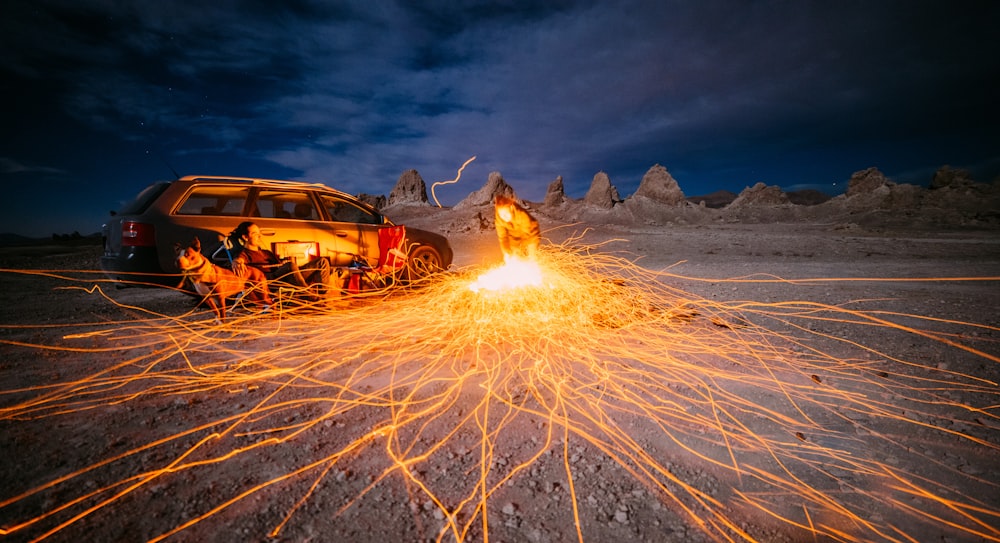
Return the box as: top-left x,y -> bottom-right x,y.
230,221 -> 330,300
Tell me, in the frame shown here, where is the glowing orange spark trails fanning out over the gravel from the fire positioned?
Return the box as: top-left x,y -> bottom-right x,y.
0,240 -> 1000,541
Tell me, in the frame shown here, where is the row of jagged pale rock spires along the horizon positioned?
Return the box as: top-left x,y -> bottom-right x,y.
359,160 -> 1000,232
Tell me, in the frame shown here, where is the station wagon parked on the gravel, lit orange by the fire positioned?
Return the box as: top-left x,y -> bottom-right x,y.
101,176 -> 453,285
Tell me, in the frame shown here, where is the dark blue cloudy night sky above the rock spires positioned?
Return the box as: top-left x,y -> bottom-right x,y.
0,0 -> 1000,237
